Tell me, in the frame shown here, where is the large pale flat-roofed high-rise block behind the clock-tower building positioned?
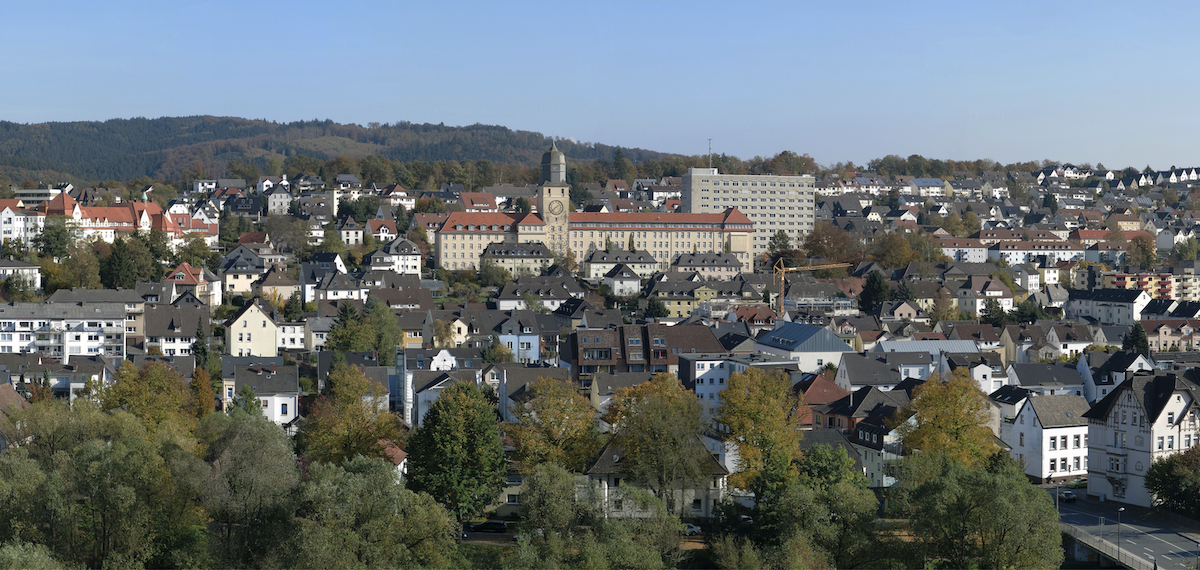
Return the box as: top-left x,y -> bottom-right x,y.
683,168 -> 816,257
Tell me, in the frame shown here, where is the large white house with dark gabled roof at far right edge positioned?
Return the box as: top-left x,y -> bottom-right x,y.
1084,371 -> 1200,506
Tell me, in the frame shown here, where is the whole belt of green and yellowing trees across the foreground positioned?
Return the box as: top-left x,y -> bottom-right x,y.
0,364 -> 1062,569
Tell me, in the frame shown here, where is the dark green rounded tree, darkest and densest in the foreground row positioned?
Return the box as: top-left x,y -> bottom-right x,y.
408,383 -> 508,518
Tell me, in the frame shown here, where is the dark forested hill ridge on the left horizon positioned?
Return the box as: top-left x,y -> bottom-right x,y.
0,115 -> 673,184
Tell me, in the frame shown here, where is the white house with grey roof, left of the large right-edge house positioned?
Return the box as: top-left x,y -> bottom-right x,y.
1001,395 -> 1088,482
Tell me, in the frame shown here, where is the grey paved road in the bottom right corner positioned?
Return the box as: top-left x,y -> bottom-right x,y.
1046,487 -> 1200,568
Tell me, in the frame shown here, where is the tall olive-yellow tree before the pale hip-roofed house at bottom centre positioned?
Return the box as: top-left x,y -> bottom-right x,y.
605,373 -> 713,512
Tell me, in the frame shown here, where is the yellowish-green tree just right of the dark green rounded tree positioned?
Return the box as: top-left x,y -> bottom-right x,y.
505,377 -> 600,473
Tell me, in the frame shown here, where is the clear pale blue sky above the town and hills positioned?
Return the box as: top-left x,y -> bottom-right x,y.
0,0 -> 1200,168
